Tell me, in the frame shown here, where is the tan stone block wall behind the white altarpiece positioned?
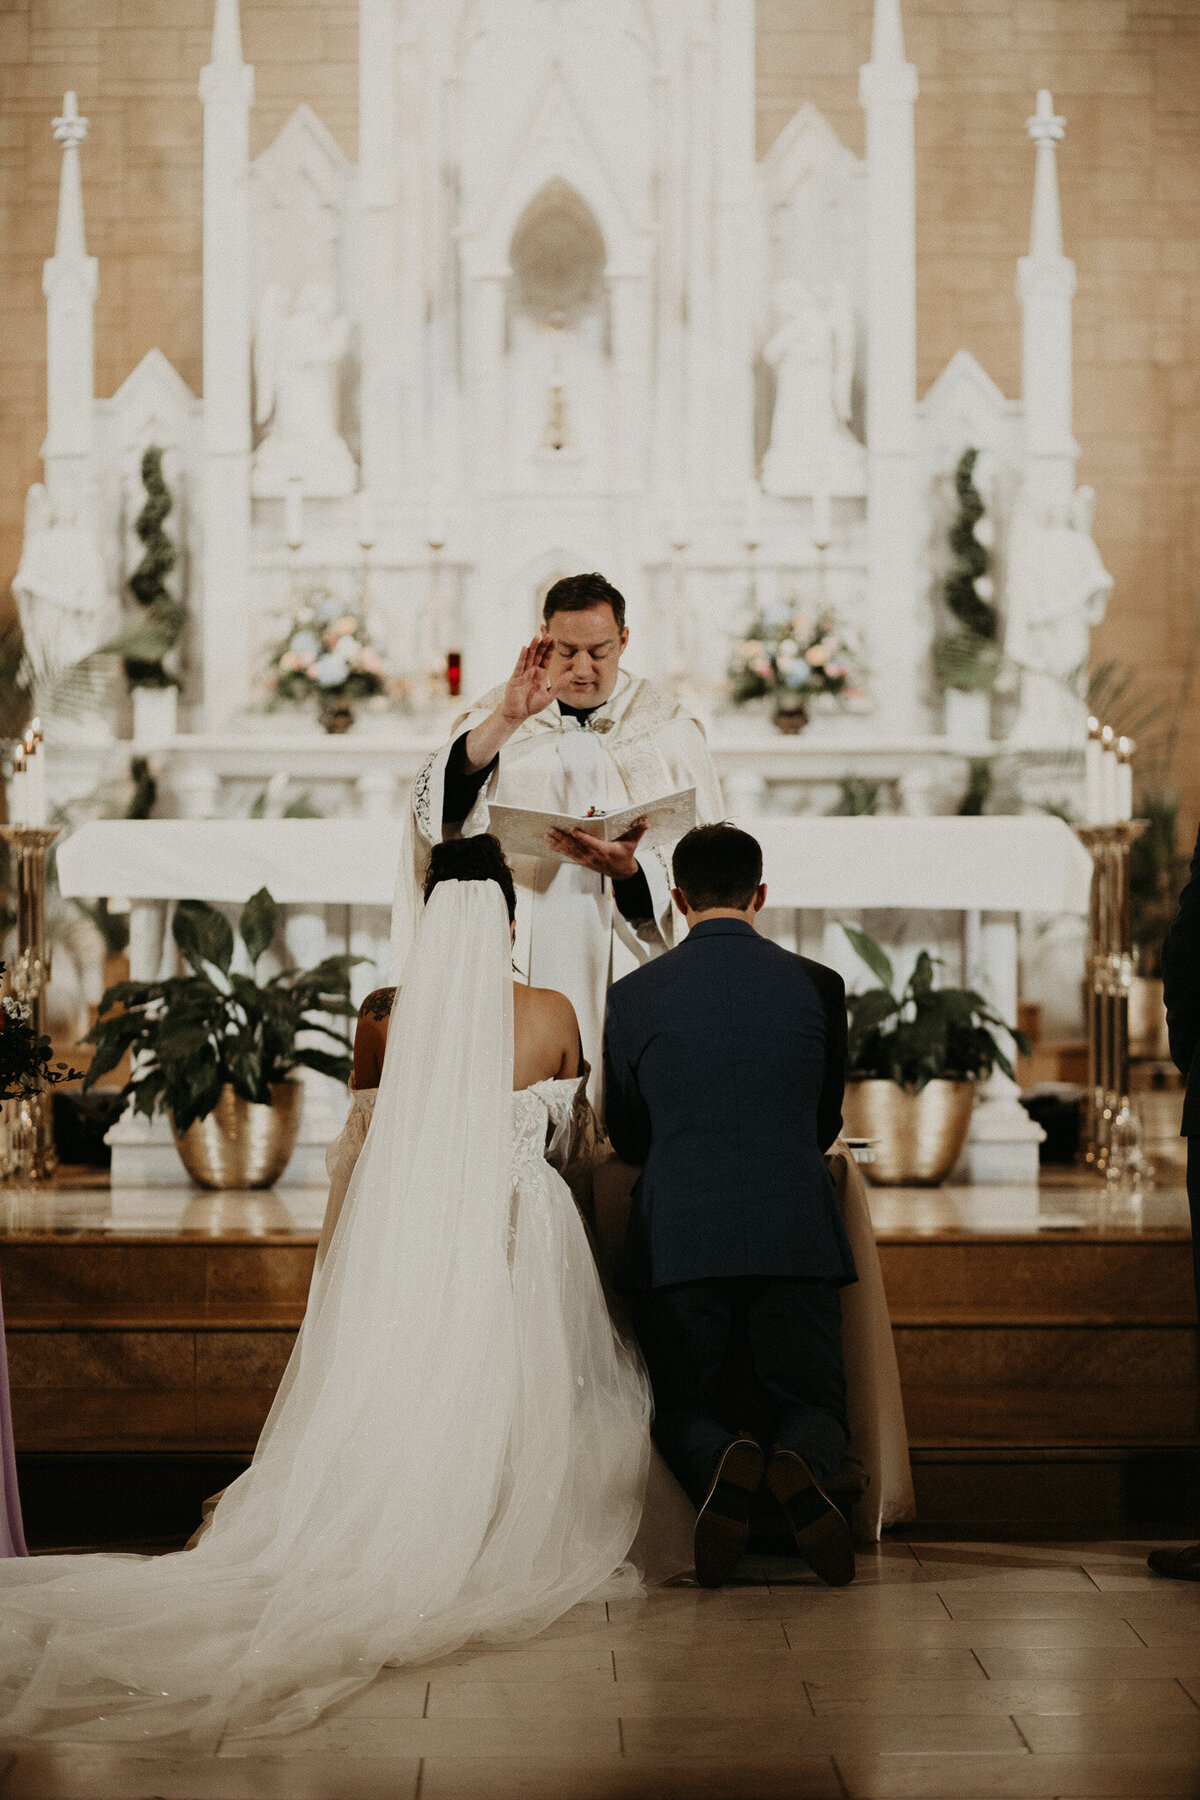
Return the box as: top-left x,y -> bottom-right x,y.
0,0 -> 1200,828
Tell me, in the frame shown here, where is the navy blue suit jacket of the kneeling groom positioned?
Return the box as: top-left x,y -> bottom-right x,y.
604,918 -> 856,1289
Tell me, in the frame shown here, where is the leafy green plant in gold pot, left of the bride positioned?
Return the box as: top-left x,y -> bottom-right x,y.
83,887 -> 362,1188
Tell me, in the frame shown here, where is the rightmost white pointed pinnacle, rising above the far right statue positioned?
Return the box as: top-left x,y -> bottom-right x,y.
1016,88 -> 1079,508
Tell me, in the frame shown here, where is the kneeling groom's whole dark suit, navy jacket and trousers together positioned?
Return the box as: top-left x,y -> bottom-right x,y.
604,918 -> 855,1505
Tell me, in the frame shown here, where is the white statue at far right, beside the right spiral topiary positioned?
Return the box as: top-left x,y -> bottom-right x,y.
1004,488 -> 1112,745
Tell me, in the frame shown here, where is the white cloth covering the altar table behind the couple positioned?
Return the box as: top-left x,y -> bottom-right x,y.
58,814 -> 1092,914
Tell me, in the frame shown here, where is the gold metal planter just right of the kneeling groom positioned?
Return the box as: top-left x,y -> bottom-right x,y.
842,1080 -> 975,1188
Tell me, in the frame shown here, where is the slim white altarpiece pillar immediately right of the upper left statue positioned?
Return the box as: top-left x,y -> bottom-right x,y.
358,0 -> 401,502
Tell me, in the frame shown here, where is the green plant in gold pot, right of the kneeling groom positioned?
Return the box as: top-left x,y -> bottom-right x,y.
842,925 -> 1029,1188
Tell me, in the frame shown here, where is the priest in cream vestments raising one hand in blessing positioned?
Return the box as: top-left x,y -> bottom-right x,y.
392,574 -> 721,1082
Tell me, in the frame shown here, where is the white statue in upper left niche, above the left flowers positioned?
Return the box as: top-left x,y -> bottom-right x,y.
252,281 -> 358,499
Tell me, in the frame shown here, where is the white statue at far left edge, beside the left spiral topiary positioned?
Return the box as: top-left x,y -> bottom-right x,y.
13,481 -> 115,689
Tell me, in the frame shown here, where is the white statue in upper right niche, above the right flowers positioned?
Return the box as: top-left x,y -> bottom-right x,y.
763,277 -> 867,499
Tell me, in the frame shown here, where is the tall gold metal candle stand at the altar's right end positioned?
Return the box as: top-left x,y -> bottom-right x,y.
1078,819 -> 1148,1175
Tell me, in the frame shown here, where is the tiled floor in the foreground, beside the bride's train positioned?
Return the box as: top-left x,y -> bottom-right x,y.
0,1537 -> 1200,1800
